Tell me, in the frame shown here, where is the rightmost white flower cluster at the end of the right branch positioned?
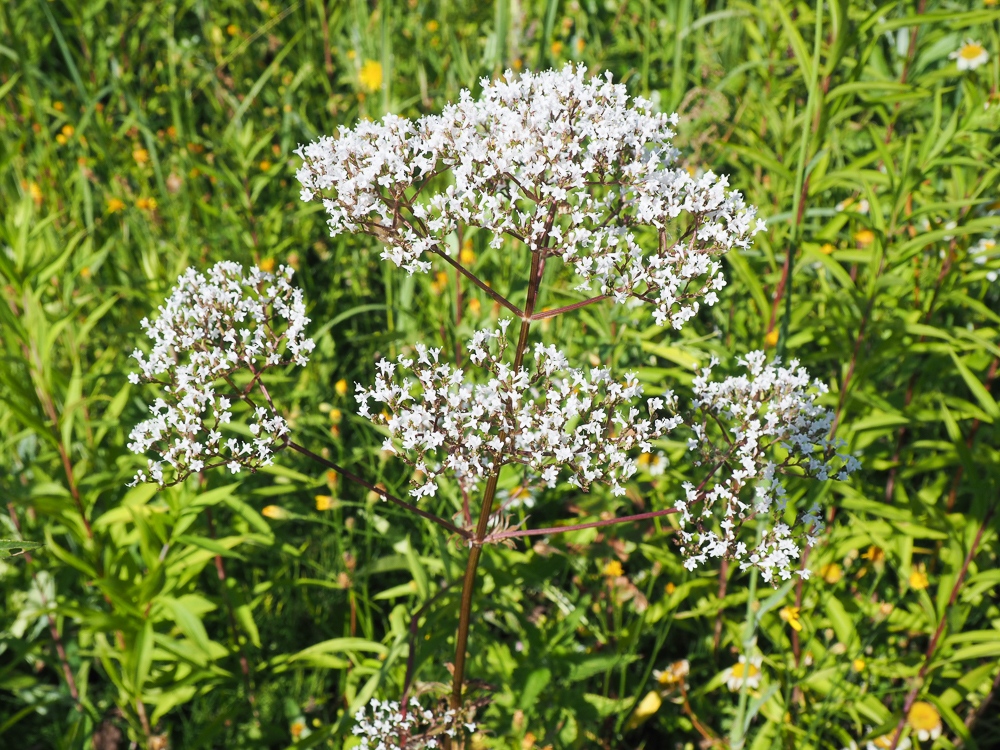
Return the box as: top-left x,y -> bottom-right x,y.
677,351 -> 861,582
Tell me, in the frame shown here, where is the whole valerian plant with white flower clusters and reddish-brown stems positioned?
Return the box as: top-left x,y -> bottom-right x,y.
132,66 -> 859,747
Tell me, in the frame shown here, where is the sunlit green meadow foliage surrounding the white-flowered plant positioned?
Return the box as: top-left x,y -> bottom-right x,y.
0,0 -> 1000,750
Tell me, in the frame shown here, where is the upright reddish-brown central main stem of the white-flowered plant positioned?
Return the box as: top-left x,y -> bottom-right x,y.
451,250 -> 551,710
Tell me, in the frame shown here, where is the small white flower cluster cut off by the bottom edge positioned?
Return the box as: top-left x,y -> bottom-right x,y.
351,698 -> 476,750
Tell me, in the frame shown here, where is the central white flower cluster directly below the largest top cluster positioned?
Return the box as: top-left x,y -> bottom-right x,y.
356,320 -> 681,498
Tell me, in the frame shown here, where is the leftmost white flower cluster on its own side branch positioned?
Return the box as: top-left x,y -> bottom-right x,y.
128,262 -> 314,485
